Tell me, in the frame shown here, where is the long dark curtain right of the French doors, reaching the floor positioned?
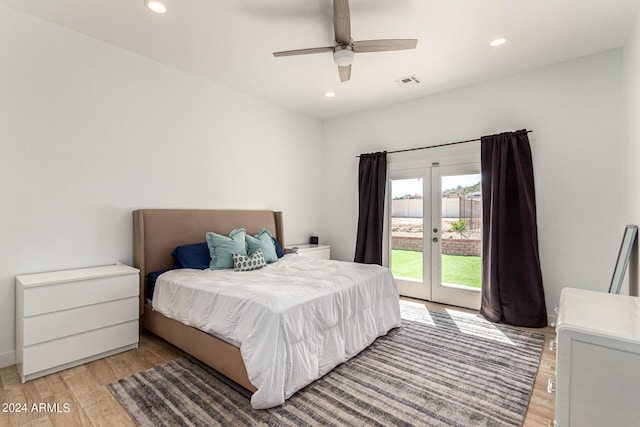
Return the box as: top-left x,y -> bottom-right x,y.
480,130 -> 547,327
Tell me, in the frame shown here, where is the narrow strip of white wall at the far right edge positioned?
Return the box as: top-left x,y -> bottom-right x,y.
623,5 -> 640,295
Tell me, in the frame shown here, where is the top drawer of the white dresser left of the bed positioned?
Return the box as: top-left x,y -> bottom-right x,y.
23,274 -> 139,317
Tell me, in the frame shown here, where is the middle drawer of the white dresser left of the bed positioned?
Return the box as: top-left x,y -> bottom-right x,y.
23,297 -> 139,346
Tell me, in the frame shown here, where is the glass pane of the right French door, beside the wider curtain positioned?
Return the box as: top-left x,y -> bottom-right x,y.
440,174 -> 482,288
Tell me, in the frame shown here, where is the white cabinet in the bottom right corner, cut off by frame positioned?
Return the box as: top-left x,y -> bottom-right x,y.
555,288 -> 640,427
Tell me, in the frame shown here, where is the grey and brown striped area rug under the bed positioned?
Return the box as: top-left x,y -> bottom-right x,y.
108,301 -> 544,426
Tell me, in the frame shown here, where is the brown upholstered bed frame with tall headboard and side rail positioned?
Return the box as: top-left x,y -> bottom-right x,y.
133,209 -> 285,392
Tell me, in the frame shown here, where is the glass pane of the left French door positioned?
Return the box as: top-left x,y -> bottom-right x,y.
390,177 -> 424,282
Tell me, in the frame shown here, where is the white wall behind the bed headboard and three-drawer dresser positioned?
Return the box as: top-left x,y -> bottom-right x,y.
0,6 -> 322,366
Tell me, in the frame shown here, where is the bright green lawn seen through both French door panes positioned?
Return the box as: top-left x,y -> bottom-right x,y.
391,249 -> 482,288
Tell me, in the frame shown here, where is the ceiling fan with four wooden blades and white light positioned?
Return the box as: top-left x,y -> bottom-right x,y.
273,0 -> 418,82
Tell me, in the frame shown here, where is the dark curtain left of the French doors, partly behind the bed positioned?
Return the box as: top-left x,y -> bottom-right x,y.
354,151 -> 387,265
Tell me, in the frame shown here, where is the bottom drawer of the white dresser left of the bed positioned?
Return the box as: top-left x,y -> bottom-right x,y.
22,320 -> 138,377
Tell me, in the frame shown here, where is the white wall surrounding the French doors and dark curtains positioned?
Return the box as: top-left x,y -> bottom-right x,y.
322,49 -> 624,320
